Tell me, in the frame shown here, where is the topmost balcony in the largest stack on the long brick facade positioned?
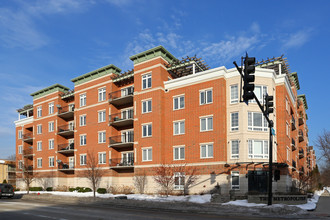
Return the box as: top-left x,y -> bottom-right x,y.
109,87 -> 134,106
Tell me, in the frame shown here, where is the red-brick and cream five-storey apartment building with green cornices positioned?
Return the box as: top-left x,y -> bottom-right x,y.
15,46 -> 316,193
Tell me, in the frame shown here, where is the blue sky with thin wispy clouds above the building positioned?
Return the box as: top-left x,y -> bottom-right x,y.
0,0 -> 330,162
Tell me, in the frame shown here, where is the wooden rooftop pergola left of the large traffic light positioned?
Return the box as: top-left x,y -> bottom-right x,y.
165,55 -> 210,78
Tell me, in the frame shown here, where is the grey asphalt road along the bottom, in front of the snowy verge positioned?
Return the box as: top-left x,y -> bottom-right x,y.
0,199 -> 288,220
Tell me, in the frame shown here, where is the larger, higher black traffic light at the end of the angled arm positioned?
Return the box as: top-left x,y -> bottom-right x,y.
243,55 -> 256,102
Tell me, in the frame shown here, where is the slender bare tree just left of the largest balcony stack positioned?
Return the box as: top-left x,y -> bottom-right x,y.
83,152 -> 105,197
